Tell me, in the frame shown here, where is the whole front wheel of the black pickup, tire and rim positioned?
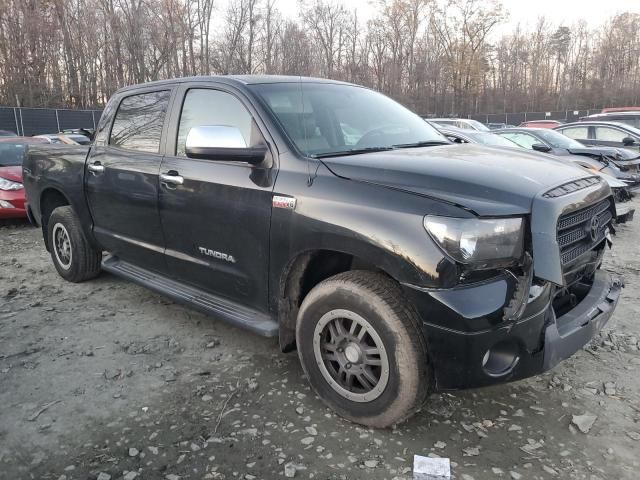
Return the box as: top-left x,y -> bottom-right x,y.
296,271 -> 430,428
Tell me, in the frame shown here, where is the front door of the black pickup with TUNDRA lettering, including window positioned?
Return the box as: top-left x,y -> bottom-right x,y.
160,84 -> 277,312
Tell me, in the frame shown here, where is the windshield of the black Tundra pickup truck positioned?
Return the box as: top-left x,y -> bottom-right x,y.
250,83 -> 449,156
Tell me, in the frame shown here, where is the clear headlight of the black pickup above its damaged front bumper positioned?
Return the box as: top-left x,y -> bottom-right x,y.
424,215 -> 524,268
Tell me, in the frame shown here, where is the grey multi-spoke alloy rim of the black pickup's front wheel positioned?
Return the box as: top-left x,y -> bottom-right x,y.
313,309 -> 389,403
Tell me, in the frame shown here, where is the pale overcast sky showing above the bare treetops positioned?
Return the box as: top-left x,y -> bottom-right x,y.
266,0 -> 640,28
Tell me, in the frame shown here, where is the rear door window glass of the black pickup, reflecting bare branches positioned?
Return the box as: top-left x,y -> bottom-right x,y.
109,90 -> 171,153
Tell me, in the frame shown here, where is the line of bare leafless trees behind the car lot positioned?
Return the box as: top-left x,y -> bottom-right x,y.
0,0 -> 640,115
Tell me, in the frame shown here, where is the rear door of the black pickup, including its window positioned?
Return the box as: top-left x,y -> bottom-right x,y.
85,89 -> 172,273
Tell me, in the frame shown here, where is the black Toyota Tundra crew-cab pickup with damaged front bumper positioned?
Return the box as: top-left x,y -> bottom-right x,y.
24,76 -> 622,427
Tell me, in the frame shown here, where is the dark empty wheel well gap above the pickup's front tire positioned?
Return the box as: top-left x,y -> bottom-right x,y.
278,250 -> 385,352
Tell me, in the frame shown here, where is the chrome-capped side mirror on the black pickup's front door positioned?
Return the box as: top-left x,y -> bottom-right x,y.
185,125 -> 268,165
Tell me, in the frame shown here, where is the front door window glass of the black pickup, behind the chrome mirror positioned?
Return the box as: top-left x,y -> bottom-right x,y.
176,88 -> 262,157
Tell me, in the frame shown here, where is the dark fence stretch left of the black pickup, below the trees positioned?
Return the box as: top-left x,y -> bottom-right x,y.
0,107 -> 102,137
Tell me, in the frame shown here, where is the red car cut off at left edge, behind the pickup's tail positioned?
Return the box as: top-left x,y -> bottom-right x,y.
0,137 -> 47,219
